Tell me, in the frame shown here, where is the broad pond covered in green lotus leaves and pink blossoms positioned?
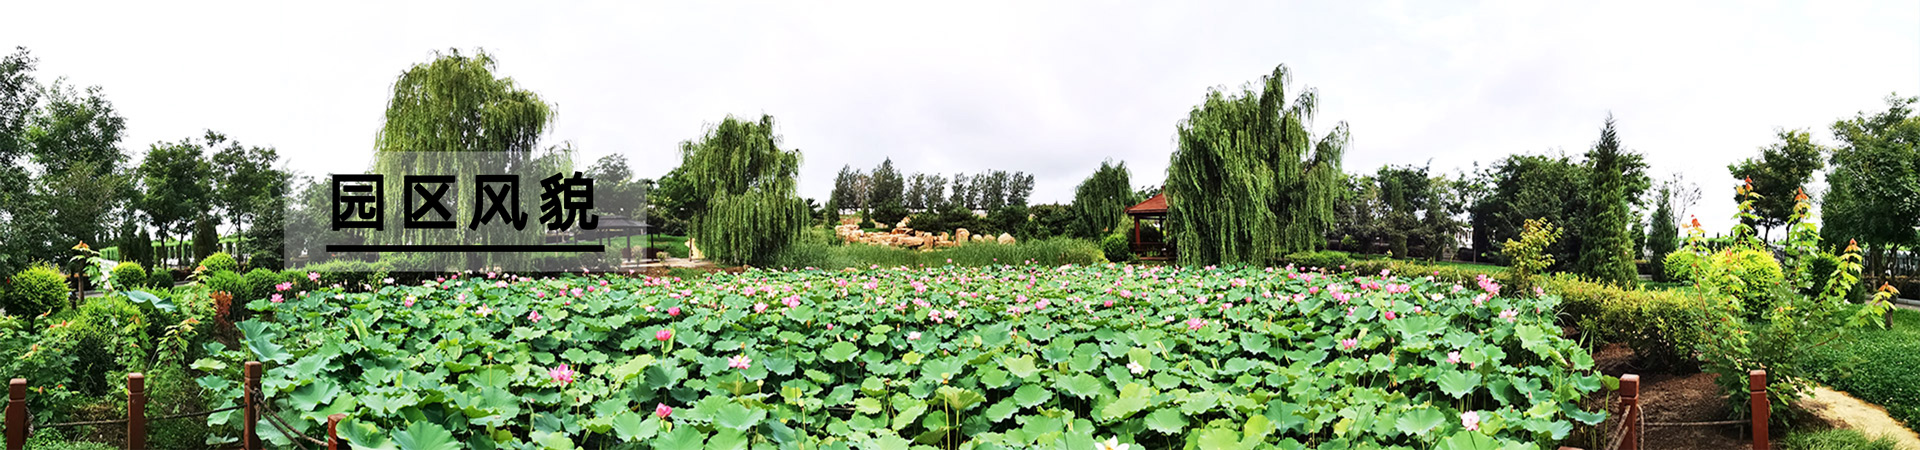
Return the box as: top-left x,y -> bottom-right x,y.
194,265 -> 1613,448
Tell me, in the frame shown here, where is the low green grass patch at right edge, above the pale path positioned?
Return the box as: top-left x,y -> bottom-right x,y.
1807,310 -> 1920,423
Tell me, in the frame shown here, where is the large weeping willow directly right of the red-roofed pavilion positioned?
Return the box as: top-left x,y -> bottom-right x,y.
1165,65 -> 1348,263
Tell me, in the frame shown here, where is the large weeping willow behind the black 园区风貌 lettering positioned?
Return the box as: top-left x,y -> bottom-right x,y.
369,50 -> 572,269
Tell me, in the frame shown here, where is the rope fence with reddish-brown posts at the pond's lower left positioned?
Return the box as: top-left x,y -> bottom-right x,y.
6,362 -> 346,450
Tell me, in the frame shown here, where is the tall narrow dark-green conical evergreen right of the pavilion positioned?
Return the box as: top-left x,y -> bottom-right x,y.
1574,115 -> 1645,287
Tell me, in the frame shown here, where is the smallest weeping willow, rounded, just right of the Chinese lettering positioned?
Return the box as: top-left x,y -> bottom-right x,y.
680,115 -> 808,263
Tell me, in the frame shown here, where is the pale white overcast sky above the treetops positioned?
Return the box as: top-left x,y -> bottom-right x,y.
0,2 -> 1920,231
